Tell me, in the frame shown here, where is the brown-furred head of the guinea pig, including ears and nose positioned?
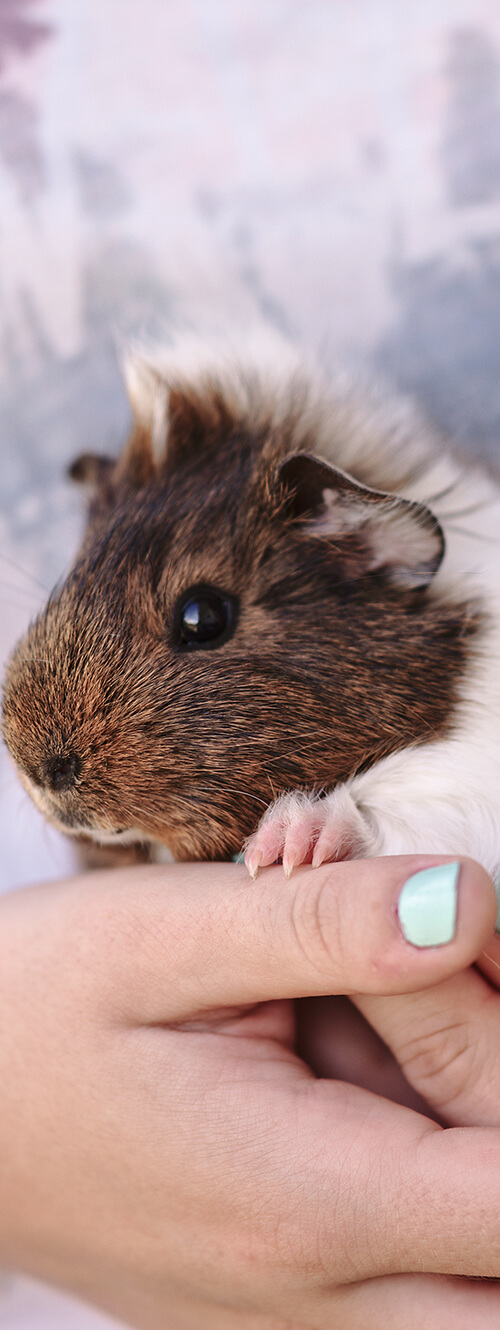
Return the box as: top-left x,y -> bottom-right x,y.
3,369 -> 472,859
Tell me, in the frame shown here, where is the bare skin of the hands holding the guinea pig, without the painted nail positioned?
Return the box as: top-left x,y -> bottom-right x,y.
0,857 -> 500,1330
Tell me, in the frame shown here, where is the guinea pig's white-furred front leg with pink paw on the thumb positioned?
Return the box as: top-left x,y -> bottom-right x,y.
245,739 -> 500,878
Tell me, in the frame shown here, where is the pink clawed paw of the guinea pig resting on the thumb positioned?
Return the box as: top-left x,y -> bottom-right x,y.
245,785 -> 376,878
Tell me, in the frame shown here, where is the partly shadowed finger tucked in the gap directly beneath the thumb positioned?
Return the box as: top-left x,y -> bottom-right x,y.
298,935 -> 500,1127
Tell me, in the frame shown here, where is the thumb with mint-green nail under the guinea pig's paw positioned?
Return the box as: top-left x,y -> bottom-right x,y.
31,855 -> 496,1024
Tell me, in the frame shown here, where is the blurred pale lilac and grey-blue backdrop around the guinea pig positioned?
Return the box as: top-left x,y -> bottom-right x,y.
0,0 -> 500,1330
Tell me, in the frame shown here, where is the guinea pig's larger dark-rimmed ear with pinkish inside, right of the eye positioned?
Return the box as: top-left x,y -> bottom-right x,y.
278,452 -> 444,589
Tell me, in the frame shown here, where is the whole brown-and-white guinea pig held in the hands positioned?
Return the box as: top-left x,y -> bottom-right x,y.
3,329 -> 500,874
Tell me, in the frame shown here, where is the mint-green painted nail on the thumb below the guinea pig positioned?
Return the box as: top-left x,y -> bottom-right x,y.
398,862 -> 460,947
